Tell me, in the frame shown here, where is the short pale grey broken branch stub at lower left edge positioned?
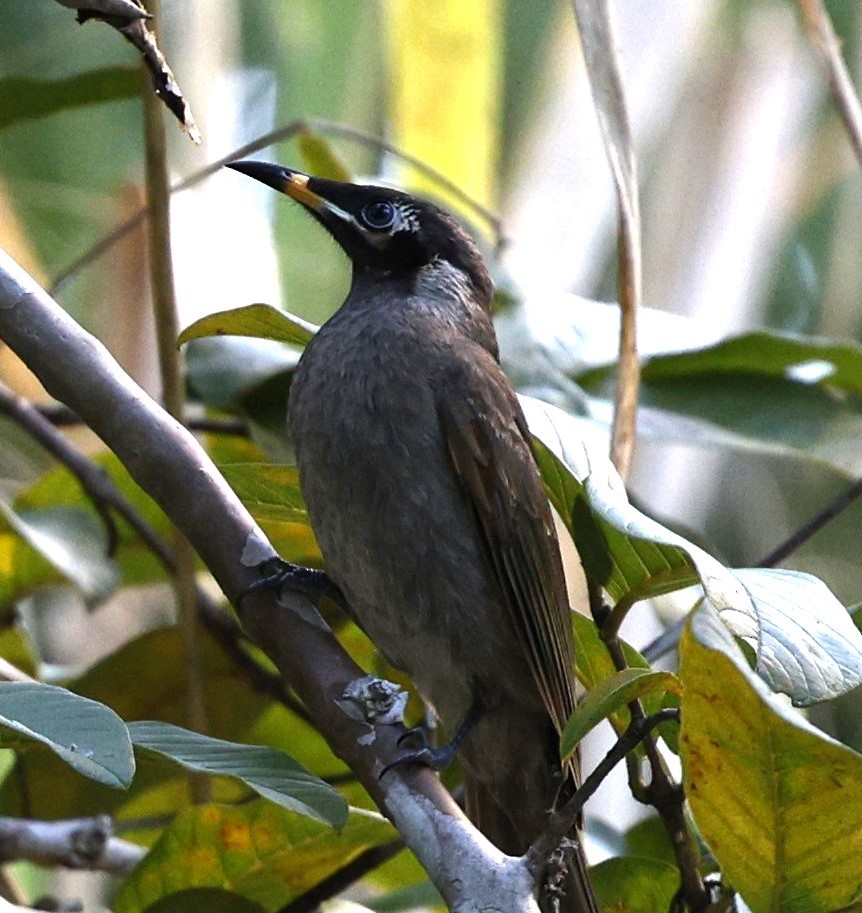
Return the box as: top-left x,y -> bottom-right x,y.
0,815 -> 147,875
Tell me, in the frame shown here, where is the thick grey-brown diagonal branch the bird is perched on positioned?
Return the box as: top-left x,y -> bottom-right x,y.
0,251 -> 537,913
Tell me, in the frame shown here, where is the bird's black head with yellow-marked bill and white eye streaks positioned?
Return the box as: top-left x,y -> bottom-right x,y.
228,162 -> 493,308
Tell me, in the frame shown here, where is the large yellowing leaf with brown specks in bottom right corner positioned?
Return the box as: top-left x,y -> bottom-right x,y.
680,609 -> 862,913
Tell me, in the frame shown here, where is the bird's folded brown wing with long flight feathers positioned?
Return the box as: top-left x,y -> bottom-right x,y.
436,343 -> 575,731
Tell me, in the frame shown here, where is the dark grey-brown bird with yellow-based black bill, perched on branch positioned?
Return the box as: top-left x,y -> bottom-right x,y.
229,162 -> 597,913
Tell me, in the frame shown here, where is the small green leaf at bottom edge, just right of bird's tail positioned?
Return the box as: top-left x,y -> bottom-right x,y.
590,856 -> 679,913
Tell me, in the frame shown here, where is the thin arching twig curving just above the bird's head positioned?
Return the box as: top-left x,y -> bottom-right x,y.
49,118 -> 506,295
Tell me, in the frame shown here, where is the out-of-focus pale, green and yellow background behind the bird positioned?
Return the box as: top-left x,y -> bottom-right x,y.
0,0 -> 862,892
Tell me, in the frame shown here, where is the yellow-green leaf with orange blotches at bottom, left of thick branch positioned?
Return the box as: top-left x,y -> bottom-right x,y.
113,802 -> 395,913
